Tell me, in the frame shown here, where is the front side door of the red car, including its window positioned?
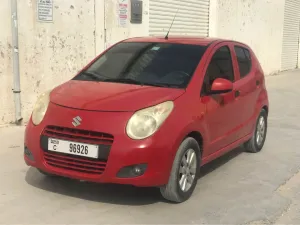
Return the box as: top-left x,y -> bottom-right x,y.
201,43 -> 241,157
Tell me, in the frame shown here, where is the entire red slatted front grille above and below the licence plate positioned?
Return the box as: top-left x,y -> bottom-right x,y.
41,126 -> 114,175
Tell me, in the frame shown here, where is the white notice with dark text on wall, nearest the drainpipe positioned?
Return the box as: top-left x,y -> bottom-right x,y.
37,0 -> 53,22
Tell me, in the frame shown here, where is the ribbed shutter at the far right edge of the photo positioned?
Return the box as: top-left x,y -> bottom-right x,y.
282,0 -> 300,70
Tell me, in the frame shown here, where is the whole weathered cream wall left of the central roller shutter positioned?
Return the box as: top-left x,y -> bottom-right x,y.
0,0 -> 149,125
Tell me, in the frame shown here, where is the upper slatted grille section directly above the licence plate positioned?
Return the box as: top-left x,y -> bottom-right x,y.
43,126 -> 114,145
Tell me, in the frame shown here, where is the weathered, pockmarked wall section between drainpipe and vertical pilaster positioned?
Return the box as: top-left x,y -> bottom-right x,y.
18,0 -> 96,121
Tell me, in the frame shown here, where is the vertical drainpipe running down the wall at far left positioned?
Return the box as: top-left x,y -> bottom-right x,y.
11,0 -> 23,124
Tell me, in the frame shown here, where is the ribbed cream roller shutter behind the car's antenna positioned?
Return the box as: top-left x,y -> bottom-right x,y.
149,0 -> 210,37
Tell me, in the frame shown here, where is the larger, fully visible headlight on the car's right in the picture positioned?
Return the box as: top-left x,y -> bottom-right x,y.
126,101 -> 174,139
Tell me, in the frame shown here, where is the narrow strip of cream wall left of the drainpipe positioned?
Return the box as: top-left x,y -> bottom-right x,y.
0,0 -> 14,124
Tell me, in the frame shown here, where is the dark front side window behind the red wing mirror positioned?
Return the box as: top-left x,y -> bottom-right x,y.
201,46 -> 234,94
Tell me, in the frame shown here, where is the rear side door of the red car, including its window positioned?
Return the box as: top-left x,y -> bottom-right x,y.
232,43 -> 260,138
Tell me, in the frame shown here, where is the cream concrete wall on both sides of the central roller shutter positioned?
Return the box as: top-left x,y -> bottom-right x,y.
0,0 -> 292,125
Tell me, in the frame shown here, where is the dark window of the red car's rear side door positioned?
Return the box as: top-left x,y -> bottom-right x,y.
234,46 -> 252,78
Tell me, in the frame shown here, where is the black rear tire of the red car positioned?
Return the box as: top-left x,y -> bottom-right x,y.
244,109 -> 268,153
